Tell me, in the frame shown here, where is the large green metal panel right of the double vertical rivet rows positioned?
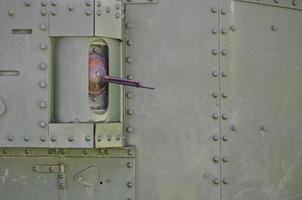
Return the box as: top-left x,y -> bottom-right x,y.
220,1 -> 302,200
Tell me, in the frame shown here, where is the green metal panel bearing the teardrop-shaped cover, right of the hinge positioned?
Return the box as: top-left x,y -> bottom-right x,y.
60,158 -> 135,200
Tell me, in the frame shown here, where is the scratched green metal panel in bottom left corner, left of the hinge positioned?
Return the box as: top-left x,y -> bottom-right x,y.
0,157 -> 58,200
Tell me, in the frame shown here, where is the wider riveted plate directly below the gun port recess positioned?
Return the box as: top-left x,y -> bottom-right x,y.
49,123 -> 94,148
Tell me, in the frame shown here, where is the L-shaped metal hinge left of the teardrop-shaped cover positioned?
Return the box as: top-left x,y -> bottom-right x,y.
33,164 -> 66,190
